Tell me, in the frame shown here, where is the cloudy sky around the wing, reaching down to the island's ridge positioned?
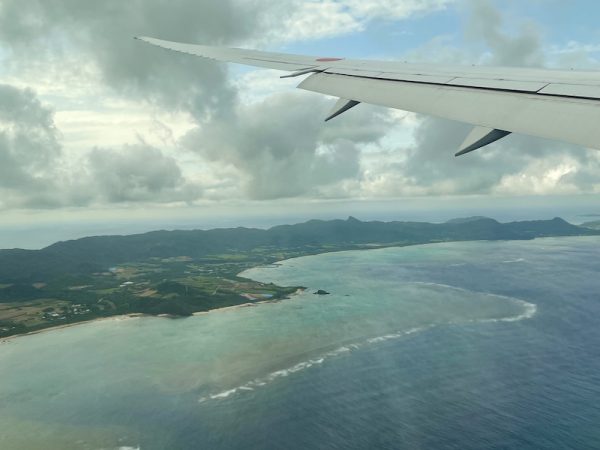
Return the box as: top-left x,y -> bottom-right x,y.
0,0 -> 600,247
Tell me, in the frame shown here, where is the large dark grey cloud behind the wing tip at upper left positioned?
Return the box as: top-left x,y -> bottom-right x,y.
0,0 -> 261,117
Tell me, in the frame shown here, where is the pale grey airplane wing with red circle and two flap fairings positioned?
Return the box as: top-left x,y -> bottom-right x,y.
137,37 -> 600,156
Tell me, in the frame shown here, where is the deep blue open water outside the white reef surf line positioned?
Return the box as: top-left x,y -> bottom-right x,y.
204,239 -> 600,449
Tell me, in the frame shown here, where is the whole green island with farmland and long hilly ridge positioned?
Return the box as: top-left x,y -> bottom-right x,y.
0,217 -> 600,337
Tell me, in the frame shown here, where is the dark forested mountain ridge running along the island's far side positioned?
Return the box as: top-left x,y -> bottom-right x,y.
0,217 -> 600,283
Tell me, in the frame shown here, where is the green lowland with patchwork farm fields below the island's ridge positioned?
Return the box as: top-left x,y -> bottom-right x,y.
0,249 -> 299,337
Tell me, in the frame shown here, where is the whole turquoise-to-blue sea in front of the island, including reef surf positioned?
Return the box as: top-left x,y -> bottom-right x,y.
0,237 -> 600,449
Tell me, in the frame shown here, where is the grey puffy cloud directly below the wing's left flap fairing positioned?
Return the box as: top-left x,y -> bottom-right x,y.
183,93 -> 389,199
